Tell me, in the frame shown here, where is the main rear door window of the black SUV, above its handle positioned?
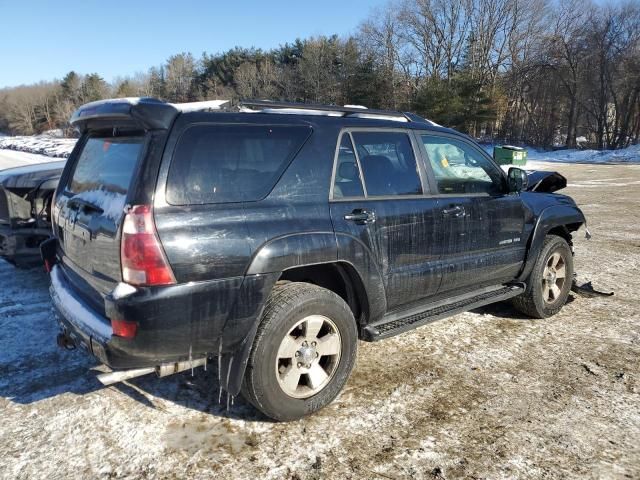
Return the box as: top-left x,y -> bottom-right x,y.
352,131 -> 422,197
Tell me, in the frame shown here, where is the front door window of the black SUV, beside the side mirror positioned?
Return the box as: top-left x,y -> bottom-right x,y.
422,135 -> 502,194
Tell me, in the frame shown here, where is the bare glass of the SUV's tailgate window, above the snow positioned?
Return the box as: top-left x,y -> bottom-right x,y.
67,137 -> 144,195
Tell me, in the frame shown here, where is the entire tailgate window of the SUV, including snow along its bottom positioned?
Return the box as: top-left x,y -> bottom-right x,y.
67,136 -> 144,220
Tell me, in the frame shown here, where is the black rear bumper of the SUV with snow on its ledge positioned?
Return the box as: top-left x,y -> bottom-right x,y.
50,264 -> 266,369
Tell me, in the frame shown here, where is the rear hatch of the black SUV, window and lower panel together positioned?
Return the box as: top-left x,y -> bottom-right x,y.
54,133 -> 146,315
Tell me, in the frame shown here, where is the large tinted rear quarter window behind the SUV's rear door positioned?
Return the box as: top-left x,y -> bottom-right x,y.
167,125 -> 311,205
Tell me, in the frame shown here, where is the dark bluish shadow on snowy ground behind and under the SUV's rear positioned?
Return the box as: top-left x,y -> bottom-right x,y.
0,260 -> 267,421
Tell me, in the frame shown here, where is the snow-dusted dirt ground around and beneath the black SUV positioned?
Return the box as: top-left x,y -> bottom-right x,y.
0,164 -> 640,480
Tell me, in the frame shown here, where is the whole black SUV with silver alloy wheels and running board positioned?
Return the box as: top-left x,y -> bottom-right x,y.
42,99 -> 585,420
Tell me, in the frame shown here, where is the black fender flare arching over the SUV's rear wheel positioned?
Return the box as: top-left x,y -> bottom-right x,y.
218,232 -> 386,396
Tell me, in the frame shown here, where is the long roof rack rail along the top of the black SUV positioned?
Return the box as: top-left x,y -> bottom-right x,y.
238,100 -> 433,123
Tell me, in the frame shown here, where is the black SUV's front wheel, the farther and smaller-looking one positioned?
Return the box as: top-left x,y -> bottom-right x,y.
511,235 -> 573,318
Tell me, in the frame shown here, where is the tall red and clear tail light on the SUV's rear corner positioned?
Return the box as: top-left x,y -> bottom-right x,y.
120,205 -> 176,286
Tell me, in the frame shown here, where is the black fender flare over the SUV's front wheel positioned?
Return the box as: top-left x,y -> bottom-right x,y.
518,205 -> 586,281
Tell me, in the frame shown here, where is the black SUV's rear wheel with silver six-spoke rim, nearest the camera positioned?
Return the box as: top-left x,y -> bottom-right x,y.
242,282 -> 358,421
